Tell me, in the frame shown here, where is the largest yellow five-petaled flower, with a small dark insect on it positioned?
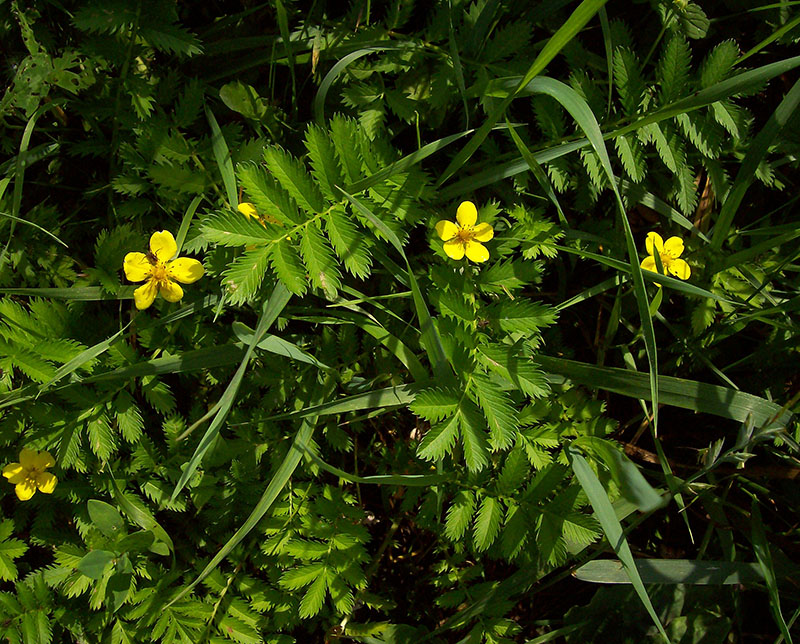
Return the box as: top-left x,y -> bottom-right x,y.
123,230 -> 205,310
